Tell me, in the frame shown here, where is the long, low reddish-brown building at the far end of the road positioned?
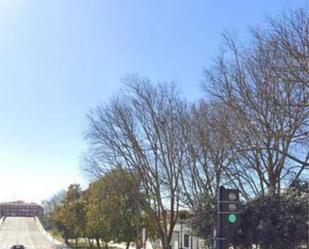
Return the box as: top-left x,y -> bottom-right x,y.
0,201 -> 44,217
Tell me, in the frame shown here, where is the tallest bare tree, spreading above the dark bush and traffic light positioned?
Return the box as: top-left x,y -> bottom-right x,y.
203,10 -> 309,193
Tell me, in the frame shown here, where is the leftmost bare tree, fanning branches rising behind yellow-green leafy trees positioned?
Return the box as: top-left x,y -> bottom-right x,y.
83,76 -> 187,249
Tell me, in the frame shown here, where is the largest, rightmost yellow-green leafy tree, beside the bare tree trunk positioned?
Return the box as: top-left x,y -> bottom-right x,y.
86,169 -> 146,248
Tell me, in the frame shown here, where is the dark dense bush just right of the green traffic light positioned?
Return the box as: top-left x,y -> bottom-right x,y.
235,188 -> 308,249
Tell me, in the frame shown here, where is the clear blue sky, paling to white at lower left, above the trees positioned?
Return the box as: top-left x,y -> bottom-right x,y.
0,0 -> 307,201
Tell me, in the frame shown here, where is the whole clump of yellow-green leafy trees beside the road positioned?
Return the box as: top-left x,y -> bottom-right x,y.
46,169 -> 155,248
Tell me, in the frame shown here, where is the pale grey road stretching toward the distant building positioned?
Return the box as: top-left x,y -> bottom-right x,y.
0,217 -> 61,249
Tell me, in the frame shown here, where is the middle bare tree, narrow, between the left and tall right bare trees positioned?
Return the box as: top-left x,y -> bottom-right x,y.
181,101 -> 241,207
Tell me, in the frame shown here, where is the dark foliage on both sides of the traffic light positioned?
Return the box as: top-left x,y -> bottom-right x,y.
192,182 -> 309,249
